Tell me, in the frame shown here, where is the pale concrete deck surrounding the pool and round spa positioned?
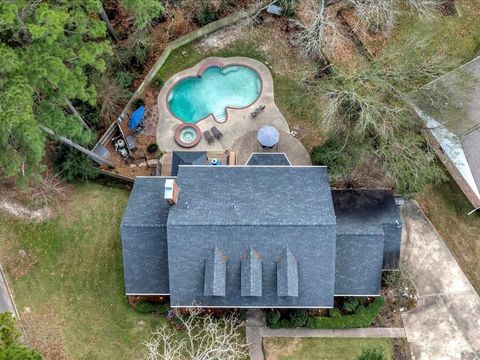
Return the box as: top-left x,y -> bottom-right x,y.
157,57 -> 292,156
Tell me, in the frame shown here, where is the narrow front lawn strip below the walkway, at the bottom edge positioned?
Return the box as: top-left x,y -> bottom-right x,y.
263,338 -> 393,360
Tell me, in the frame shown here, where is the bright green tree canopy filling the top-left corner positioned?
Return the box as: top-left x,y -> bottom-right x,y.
0,0 -> 111,186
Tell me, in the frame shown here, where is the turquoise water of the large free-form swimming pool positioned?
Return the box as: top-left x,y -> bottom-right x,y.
168,65 -> 261,123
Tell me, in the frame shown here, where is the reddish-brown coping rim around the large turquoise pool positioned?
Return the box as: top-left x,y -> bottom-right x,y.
164,58 -> 263,124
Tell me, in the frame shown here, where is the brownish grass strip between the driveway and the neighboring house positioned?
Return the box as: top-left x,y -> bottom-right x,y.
417,178 -> 480,294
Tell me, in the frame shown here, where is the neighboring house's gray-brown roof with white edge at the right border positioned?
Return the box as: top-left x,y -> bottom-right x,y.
415,57 -> 480,207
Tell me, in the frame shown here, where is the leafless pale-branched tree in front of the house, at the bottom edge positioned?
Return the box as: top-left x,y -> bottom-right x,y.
145,308 -> 248,360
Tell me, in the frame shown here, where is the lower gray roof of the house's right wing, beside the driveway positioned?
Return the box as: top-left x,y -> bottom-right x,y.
332,190 -> 402,295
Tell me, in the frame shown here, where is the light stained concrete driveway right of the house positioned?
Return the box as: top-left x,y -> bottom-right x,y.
402,201 -> 480,360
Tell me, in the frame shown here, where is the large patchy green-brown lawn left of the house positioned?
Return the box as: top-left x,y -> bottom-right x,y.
0,184 -> 171,360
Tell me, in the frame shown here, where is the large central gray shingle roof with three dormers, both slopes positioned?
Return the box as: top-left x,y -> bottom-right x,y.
168,166 -> 335,307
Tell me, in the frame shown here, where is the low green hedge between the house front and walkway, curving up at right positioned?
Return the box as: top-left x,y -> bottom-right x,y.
306,297 -> 385,329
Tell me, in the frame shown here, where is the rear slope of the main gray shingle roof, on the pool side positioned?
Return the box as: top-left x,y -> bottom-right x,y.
168,166 -> 335,226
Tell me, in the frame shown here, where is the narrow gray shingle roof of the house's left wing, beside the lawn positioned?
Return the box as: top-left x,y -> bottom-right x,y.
120,176 -> 170,295
